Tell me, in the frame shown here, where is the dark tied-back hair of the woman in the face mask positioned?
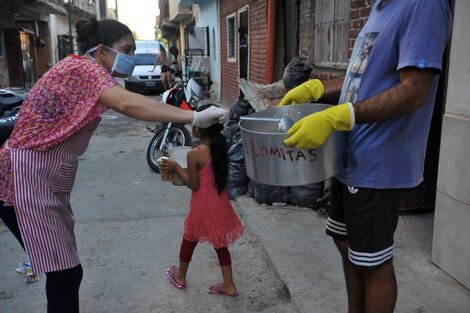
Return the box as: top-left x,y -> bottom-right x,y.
75,18 -> 132,53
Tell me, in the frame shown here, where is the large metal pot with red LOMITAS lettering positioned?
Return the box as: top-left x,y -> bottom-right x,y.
239,103 -> 345,186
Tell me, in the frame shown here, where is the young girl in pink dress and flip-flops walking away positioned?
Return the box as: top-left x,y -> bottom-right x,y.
162,104 -> 243,297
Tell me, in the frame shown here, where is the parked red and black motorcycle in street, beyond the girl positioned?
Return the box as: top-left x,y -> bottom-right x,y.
147,78 -> 203,173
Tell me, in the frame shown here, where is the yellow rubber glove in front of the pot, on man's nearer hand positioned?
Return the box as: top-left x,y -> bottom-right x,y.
284,103 -> 355,149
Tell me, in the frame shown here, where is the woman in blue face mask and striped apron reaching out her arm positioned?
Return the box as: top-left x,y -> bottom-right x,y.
0,20 -> 227,313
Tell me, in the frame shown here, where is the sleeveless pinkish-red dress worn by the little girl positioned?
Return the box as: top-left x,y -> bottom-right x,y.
183,147 -> 244,249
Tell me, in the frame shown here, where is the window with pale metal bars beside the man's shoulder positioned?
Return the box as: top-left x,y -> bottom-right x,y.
315,0 -> 351,68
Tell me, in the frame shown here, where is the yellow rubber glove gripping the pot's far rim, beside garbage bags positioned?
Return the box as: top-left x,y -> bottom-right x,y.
279,79 -> 325,106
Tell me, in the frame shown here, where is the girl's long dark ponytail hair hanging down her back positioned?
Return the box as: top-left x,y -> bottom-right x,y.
196,104 -> 228,194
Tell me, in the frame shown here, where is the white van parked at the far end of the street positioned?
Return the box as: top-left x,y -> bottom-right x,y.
124,40 -> 164,93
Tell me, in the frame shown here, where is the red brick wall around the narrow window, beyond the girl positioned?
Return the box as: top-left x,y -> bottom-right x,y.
220,0 -> 267,105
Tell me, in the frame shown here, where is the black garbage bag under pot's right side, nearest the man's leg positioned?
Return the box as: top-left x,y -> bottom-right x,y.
290,182 -> 325,209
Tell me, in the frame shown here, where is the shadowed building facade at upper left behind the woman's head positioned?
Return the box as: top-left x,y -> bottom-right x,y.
0,0 -> 115,88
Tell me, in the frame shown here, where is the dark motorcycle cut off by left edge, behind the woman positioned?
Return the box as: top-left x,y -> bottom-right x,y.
0,87 -> 27,146
